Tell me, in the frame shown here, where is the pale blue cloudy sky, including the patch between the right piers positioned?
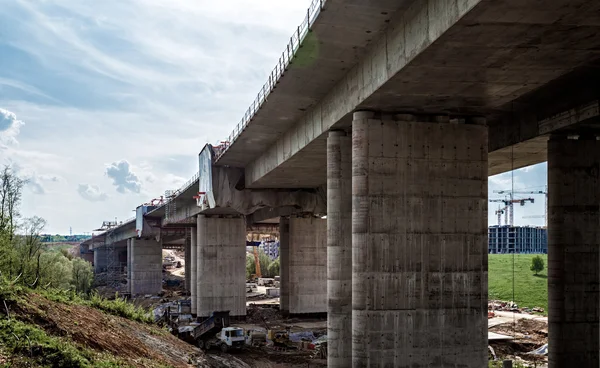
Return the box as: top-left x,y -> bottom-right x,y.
0,0 -> 546,234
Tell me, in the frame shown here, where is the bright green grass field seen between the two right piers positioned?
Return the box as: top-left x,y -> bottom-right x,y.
488,254 -> 548,314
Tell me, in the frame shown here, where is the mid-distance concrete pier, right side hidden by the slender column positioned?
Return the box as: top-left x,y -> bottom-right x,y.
279,216 -> 327,314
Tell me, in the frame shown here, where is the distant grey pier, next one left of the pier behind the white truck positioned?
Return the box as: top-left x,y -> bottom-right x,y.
130,238 -> 162,294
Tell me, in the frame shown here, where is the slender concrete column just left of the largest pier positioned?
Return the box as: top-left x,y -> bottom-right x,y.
327,131 -> 352,368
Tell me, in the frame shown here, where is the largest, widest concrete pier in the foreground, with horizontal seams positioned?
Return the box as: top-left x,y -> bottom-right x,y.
352,112 -> 488,368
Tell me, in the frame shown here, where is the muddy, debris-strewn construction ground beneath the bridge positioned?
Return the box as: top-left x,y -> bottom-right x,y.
94,254 -> 548,368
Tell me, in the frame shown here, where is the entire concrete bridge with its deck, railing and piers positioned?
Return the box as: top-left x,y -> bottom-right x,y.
83,0 -> 600,368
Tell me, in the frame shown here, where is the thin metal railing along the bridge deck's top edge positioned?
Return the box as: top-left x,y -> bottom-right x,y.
216,0 -> 327,159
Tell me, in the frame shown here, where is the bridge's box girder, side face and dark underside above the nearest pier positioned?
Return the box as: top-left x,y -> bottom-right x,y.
229,0 -> 600,188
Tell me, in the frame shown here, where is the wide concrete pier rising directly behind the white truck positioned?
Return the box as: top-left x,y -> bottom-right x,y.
196,215 -> 246,317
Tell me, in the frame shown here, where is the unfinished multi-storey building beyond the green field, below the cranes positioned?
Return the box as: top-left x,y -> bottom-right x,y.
488,225 -> 548,254
